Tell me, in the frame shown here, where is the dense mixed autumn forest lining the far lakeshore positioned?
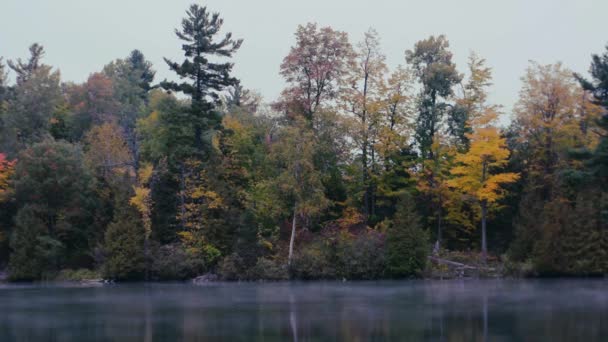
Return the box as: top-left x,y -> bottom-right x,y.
0,5 -> 608,281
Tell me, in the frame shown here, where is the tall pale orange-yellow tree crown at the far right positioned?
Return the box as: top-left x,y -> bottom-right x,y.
514,62 -> 602,191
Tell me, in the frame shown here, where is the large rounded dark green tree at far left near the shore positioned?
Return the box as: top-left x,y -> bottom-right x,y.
11,140 -> 99,278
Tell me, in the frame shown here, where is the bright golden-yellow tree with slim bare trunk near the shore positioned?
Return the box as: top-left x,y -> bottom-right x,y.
447,111 -> 519,261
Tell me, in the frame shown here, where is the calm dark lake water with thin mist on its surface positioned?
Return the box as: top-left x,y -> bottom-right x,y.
0,280 -> 608,341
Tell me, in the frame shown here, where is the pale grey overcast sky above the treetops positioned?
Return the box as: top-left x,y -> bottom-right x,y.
0,0 -> 608,118
